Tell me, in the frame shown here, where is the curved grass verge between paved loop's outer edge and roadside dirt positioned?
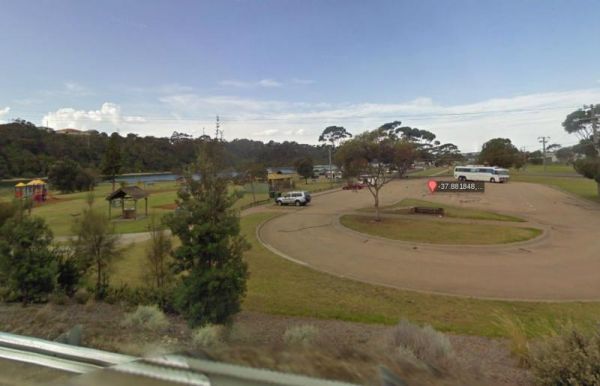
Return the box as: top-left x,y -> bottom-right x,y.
242,213 -> 600,337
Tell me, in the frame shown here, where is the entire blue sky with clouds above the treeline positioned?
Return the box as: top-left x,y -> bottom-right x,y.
0,0 -> 600,152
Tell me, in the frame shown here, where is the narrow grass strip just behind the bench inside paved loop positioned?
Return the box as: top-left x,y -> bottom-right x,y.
360,198 -> 525,222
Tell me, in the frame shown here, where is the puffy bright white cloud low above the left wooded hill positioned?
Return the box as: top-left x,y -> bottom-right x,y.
42,102 -> 146,130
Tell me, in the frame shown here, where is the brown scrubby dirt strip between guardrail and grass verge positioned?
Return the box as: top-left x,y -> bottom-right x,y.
0,302 -> 529,385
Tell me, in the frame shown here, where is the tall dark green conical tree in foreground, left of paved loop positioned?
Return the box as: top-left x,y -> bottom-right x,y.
166,139 -> 249,326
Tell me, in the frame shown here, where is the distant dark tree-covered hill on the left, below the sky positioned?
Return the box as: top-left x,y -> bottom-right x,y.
0,121 -> 327,179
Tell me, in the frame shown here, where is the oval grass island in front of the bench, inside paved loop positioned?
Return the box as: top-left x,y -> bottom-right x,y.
340,215 -> 542,244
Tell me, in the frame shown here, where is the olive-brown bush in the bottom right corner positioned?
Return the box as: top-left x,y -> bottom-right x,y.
531,328 -> 600,385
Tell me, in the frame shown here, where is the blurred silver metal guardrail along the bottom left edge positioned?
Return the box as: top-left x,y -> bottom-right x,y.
0,333 -> 351,386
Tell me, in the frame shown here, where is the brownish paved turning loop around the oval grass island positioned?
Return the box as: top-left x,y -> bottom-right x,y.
259,180 -> 600,300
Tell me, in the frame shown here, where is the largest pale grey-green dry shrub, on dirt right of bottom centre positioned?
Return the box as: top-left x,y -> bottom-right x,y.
392,320 -> 453,368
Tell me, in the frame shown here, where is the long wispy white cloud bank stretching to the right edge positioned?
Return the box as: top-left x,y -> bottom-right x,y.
154,89 -> 600,151
